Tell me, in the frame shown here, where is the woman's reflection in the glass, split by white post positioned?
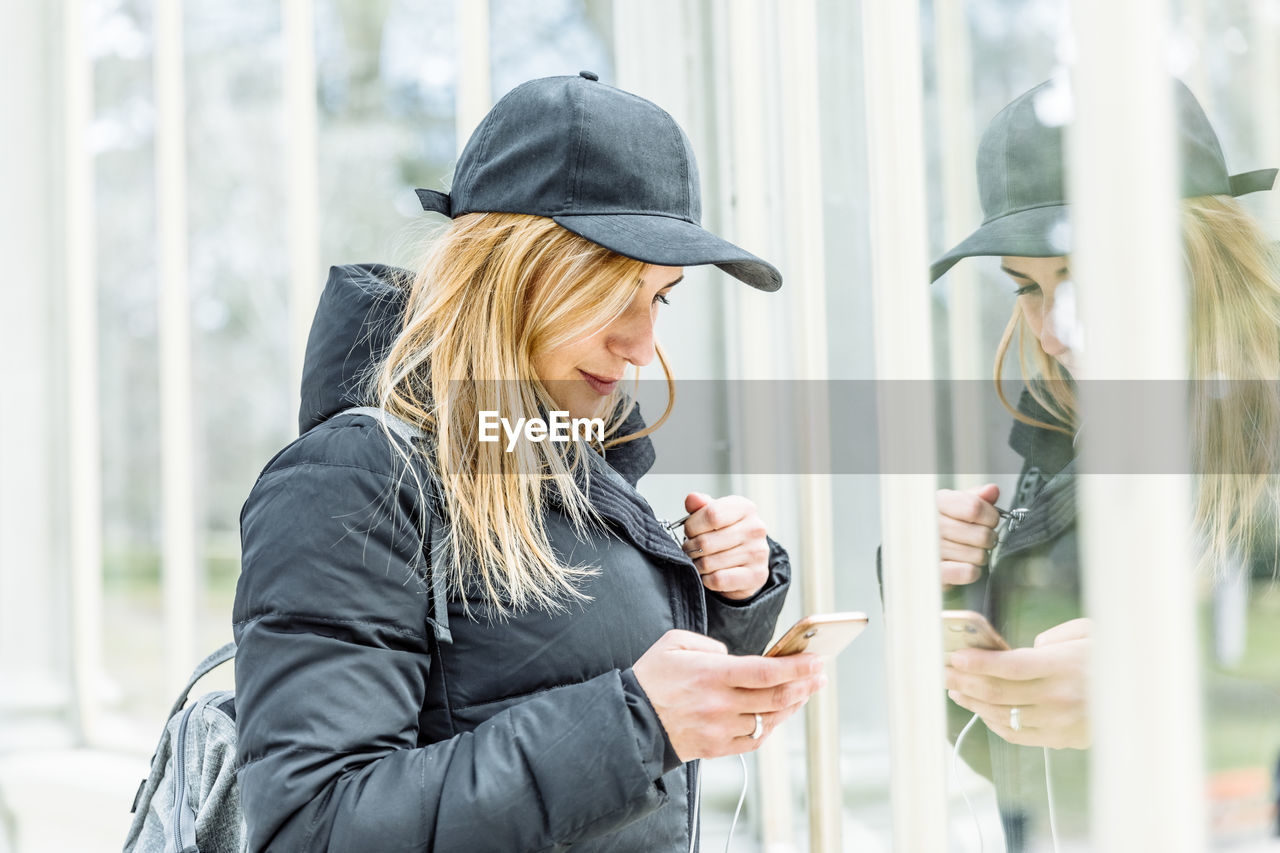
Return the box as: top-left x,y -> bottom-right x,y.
932,82 -> 1280,849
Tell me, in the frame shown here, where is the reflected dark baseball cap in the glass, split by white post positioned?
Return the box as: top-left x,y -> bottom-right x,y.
929,79 -> 1276,280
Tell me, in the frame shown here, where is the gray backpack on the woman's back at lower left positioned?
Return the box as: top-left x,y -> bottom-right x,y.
124,643 -> 248,853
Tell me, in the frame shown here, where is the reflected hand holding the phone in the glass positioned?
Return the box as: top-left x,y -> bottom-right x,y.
946,619 -> 1092,749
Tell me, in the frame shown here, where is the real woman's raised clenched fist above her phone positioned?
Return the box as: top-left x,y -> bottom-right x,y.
681,492 -> 769,601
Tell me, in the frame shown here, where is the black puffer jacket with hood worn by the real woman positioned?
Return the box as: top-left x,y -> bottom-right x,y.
234,266 -> 790,853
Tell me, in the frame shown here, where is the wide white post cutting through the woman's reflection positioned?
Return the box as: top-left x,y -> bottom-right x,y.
1068,0 -> 1206,852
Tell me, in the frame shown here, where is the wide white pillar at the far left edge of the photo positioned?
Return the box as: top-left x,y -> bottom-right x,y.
0,4 -> 66,732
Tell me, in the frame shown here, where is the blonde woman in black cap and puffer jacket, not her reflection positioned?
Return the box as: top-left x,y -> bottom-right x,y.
236,72 -> 824,850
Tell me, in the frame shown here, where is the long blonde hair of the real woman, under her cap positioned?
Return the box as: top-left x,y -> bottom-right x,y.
376,213 -> 675,616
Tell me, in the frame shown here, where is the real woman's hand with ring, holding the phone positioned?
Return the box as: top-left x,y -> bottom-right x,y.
631,630 -> 827,761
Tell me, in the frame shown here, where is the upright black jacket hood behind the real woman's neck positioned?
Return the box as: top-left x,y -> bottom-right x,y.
298,264 -> 413,434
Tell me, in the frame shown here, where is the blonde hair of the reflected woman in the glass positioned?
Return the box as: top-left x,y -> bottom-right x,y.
995,196 -> 1280,574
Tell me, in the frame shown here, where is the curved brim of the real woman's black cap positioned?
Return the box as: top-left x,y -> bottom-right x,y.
552,214 -> 782,291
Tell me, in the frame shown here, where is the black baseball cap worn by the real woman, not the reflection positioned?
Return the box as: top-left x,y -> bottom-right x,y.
417,72 -> 782,291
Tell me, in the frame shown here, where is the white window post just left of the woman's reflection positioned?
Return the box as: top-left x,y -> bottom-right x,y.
863,3 -> 947,852
